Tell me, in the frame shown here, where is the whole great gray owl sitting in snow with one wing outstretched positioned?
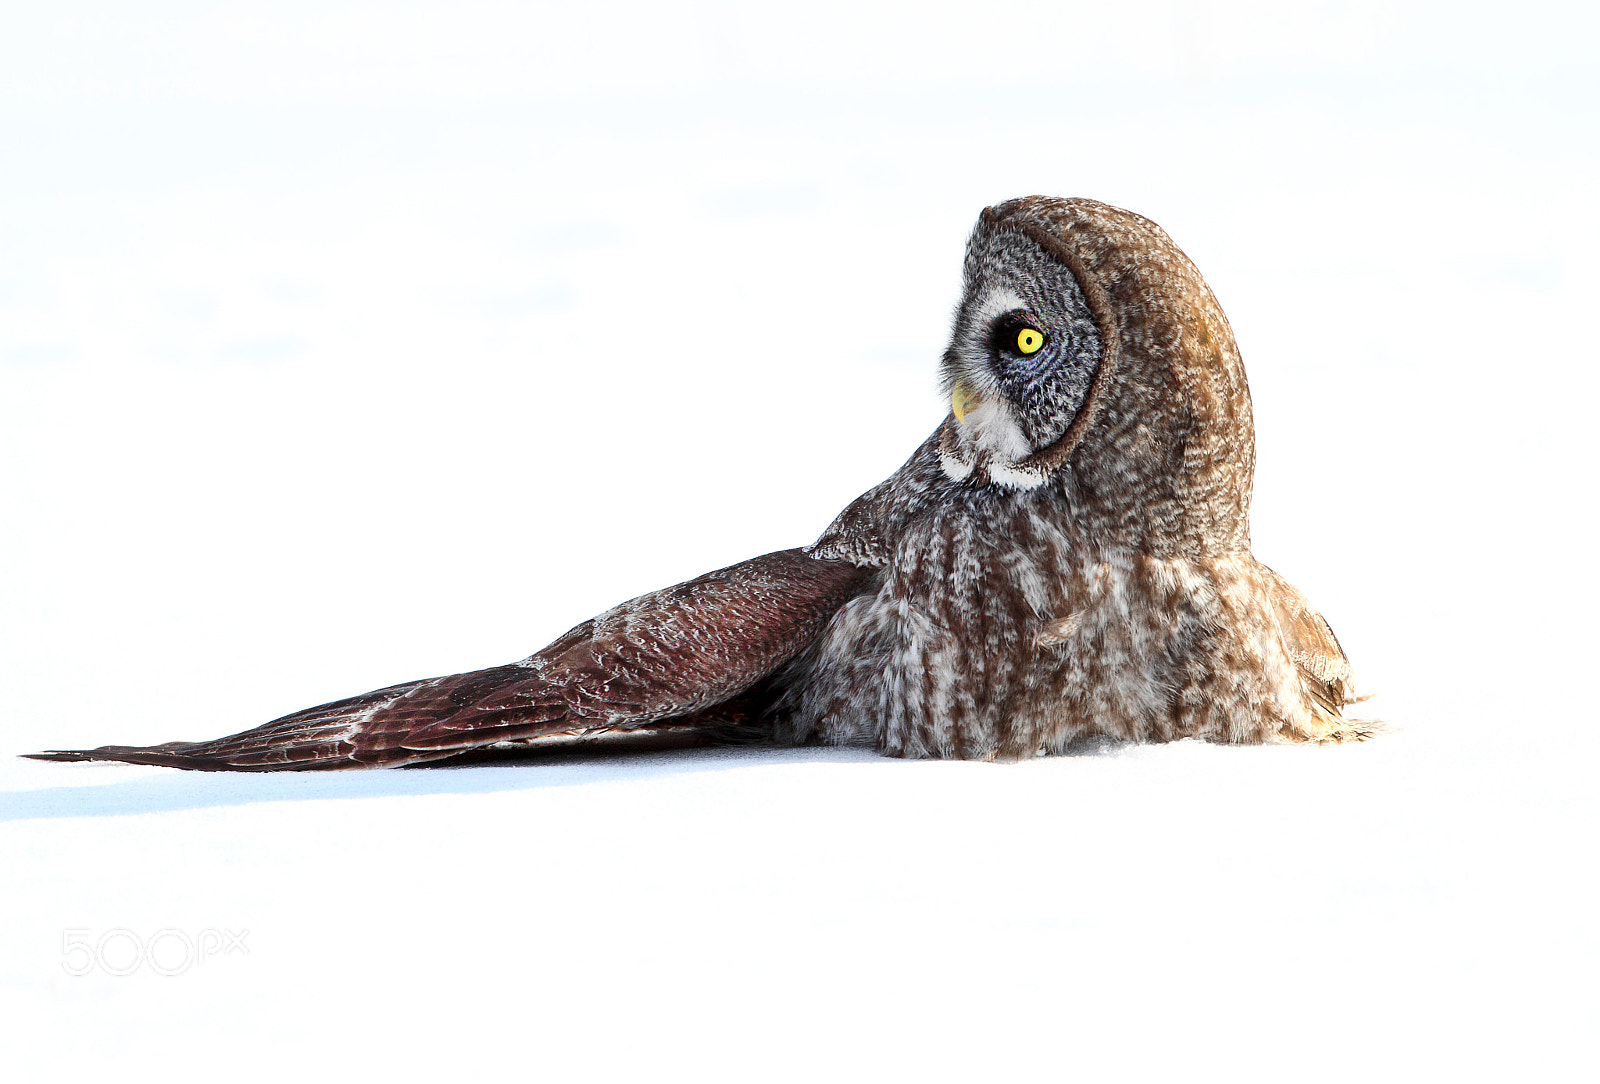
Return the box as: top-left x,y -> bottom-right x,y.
25,197 -> 1370,771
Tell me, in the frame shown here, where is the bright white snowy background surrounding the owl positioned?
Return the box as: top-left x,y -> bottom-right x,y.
0,0 -> 1600,1081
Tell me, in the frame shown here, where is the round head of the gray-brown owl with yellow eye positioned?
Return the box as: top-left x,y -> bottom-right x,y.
939,197 -> 1254,550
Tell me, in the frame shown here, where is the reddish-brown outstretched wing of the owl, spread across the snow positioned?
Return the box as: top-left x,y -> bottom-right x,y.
34,550 -> 872,771
